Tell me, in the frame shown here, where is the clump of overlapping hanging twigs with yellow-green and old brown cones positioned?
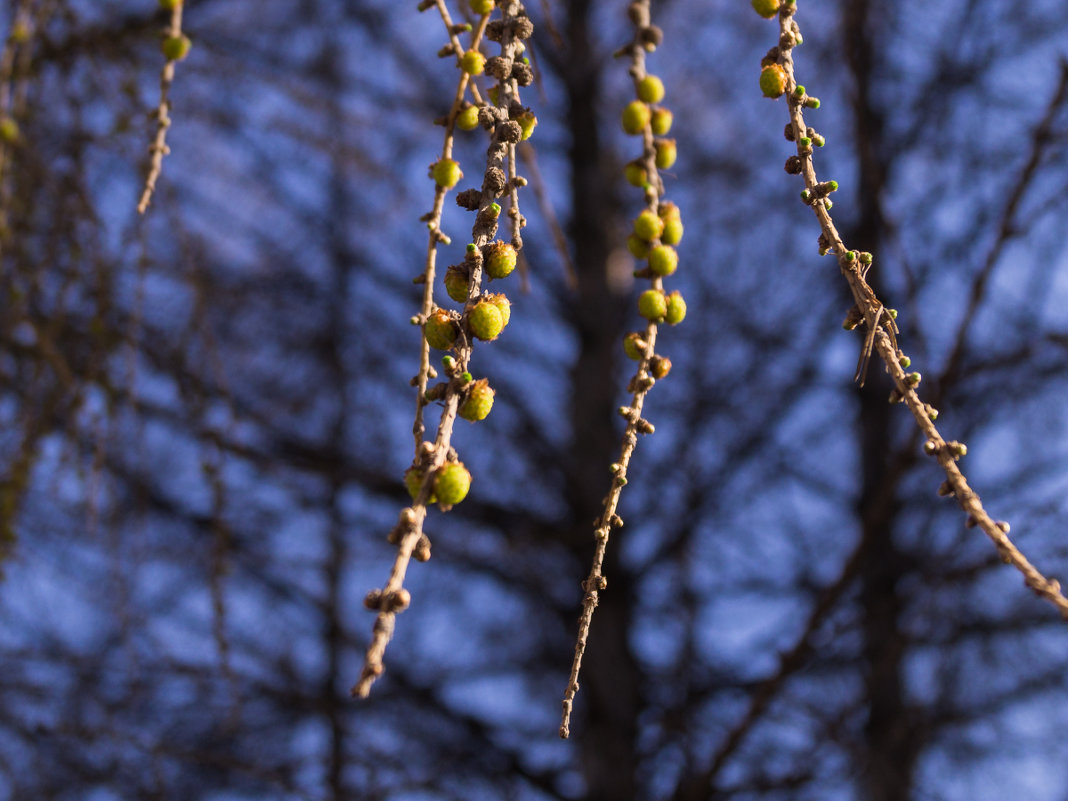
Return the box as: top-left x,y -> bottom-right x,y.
351,0 -> 537,697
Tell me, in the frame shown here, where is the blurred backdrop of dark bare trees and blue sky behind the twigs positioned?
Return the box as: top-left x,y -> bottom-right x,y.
0,0 -> 1068,801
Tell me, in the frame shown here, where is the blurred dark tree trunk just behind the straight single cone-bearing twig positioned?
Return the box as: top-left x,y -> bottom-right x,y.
565,0 -> 639,801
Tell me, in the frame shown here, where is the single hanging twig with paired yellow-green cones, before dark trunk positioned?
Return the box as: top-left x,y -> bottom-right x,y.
560,0 -> 686,738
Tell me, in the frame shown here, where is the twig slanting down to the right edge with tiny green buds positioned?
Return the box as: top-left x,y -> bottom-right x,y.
754,0 -> 1068,619
